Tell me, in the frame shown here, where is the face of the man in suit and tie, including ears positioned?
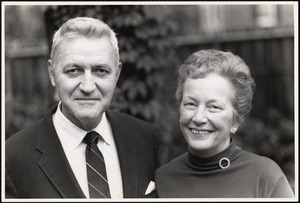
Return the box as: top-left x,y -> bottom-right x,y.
48,37 -> 121,130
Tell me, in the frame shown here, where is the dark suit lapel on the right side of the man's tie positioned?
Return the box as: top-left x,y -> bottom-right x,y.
107,111 -> 137,198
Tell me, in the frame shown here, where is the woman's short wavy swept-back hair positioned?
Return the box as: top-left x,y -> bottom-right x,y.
176,49 -> 255,122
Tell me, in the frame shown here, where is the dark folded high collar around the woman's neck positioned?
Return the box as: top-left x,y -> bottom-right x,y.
187,139 -> 241,171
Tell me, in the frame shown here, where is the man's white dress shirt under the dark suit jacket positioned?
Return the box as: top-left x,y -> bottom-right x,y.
52,102 -> 123,199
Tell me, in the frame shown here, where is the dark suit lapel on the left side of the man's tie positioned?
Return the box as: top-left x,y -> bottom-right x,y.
36,107 -> 85,198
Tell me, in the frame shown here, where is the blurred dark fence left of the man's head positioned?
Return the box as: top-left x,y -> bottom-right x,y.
5,48 -> 53,138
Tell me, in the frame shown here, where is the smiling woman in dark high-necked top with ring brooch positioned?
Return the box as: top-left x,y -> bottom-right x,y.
156,50 -> 294,198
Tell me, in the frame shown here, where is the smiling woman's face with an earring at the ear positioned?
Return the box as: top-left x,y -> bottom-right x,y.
179,74 -> 238,157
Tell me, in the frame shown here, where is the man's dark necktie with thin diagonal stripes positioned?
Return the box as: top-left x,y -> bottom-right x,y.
83,131 -> 110,198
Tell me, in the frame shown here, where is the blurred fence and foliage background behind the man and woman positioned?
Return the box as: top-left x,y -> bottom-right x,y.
4,2 -> 296,193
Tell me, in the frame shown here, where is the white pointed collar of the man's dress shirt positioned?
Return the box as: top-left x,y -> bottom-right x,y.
54,101 -> 112,150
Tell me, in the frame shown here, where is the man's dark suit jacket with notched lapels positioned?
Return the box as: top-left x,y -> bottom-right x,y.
5,106 -> 158,198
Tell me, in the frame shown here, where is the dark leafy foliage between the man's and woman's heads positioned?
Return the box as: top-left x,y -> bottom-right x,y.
103,6 -> 178,163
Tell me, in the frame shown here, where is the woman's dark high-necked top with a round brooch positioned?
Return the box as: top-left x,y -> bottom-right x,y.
156,141 -> 294,198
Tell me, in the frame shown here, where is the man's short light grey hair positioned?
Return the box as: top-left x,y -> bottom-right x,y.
50,17 -> 120,65
